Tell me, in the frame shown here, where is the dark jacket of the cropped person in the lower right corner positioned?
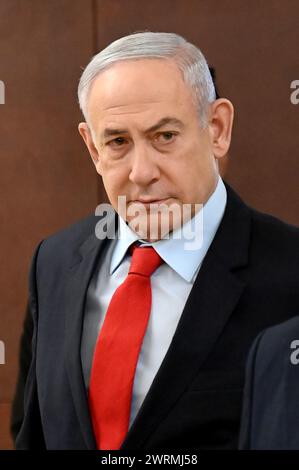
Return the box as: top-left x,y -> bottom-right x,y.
240,314 -> 299,450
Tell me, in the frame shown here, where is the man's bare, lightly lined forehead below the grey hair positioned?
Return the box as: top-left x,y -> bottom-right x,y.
88,59 -> 197,129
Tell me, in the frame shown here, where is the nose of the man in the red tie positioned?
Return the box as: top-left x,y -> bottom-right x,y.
129,143 -> 160,186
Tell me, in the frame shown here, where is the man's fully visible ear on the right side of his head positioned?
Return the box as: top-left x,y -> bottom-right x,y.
209,98 -> 234,158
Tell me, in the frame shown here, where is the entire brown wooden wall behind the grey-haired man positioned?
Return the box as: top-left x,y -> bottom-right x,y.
0,0 -> 299,449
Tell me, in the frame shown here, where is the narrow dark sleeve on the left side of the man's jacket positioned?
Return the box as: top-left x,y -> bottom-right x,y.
16,242 -> 46,450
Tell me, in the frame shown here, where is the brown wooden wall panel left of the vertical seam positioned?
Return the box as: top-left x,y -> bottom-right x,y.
0,0 -> 98,448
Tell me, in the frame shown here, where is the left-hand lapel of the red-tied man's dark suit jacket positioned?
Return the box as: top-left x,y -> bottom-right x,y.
65,208 -> 117,449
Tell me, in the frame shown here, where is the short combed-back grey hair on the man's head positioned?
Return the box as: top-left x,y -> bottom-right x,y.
78,31 -> 216,126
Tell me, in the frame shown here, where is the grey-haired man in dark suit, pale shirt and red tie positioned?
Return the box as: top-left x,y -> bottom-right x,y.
17,32 -> 299,450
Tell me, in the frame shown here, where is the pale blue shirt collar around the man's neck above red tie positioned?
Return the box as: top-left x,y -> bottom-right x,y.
110,176 -> 227,282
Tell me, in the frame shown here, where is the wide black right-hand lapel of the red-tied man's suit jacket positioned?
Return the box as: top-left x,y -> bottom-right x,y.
121,186 -> 251,449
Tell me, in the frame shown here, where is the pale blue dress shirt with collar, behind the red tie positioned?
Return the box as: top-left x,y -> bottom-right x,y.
81,177 -> 227,426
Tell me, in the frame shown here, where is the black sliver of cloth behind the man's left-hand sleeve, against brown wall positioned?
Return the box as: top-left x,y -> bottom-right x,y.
10,302 -> 33,443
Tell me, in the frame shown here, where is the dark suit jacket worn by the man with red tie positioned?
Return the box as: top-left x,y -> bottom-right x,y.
17,186 -> 299,450
